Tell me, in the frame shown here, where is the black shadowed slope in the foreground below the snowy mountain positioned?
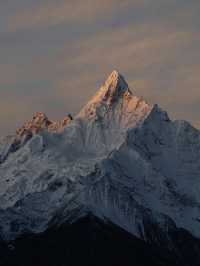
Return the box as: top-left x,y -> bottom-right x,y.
0,216 -> 200,266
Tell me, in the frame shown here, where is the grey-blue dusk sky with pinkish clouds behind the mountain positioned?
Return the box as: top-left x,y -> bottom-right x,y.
0,0 -> 200,136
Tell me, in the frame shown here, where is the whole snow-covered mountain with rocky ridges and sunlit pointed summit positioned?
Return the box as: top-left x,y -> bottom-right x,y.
0,71 -> 200,244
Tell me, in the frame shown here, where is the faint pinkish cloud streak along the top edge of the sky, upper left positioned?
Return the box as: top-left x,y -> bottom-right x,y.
8,0 -> 146,31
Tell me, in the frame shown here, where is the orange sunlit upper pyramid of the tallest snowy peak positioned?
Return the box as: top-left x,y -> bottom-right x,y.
77,70 -> 153,124
